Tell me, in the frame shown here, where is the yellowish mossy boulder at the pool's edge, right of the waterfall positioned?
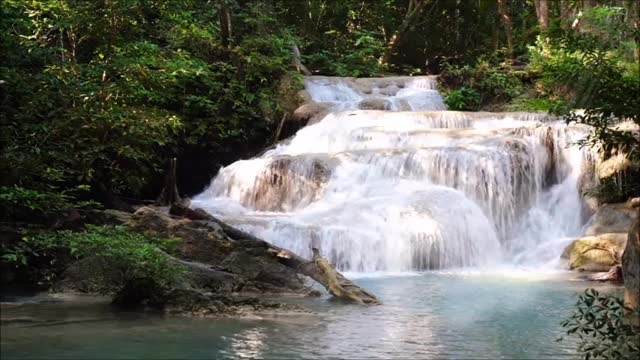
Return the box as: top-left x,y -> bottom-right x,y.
562,233 -> 627,271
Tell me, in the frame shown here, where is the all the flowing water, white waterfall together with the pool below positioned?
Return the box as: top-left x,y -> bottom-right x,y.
0,77 -> 604,359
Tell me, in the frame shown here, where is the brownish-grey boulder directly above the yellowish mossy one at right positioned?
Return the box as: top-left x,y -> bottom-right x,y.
585,203 -> 637,236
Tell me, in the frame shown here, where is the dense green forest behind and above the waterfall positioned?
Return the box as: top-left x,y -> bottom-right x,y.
0,0 -> 640,218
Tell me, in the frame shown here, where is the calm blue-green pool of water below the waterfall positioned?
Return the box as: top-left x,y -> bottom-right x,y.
0,272 -> 619,360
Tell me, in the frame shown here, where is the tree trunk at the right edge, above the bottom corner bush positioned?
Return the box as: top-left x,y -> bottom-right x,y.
622,198 -> 640,325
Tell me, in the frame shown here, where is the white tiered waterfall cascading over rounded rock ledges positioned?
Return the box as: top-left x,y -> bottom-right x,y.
194,77 -> 587,272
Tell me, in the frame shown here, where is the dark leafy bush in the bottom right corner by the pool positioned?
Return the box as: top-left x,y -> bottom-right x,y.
559,289 -> 640,360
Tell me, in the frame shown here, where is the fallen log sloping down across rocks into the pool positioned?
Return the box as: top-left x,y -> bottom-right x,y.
169,204 -> 381,304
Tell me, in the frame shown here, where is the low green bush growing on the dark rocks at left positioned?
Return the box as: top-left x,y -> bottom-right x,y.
1,225 -> 183,294
